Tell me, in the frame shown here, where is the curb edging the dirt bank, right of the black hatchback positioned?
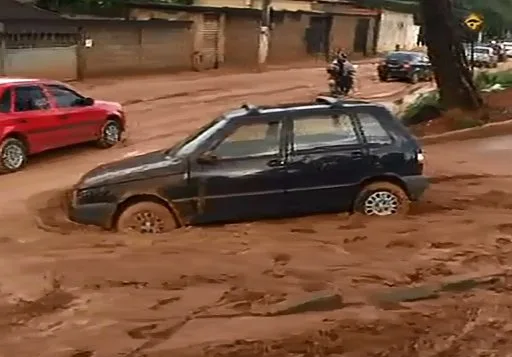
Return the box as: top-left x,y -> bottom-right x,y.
418,119 -> 512,145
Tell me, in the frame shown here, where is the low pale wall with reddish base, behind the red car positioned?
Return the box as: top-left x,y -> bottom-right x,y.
4,46 -> 77,81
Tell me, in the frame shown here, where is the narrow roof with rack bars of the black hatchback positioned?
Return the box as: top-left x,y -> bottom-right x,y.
224,97 -> 387,119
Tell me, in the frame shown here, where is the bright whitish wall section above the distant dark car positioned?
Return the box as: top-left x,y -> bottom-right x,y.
377,11 -> 419,53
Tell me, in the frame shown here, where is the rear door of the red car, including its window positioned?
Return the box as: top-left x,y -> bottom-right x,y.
10,84 -> 62,153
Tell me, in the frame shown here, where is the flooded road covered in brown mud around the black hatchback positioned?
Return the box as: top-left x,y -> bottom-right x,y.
0,66 -> 512,357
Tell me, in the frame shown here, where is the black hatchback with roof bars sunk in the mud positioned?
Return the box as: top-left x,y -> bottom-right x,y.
66,97 -> 428,233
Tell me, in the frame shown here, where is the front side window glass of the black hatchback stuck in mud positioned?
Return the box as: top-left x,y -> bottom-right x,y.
213,121 -> 282,159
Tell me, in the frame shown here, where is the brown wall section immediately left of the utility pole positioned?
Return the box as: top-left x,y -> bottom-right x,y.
224,14 -> 260,67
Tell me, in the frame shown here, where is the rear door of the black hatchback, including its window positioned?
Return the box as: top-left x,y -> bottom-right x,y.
285,109 -> 368,213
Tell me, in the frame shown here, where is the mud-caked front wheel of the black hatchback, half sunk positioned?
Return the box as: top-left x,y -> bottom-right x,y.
115,202 -> 177,234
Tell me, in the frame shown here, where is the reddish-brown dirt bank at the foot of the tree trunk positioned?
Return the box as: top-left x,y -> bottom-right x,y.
410,88 -> 512,136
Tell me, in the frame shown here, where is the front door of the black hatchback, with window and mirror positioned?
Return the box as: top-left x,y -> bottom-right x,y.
190,117 -> 285,223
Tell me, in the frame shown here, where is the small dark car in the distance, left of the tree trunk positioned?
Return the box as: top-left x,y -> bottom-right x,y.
377,51 -> 433,83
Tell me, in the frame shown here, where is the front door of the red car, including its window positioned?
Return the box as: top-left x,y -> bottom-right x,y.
45,83 -> 106,144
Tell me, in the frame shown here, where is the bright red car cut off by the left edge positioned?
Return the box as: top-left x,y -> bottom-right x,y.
0,78 -> 125,173
